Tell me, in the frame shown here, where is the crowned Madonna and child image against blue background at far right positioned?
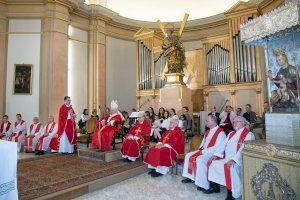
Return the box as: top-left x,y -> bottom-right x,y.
267,30 -> 300,112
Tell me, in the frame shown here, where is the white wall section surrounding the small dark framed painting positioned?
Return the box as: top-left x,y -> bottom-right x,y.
5,19 -> 41,124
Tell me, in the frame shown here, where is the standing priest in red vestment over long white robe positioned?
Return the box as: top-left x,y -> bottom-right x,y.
57,96 -> 77,154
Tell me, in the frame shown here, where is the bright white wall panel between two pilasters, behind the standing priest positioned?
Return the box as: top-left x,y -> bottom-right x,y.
68,26 -> 88,121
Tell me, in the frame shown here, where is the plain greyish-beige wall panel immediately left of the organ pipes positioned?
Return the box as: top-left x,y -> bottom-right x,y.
106,37 -> 136,111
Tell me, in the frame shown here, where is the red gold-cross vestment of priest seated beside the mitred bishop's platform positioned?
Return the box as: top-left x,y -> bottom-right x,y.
121,120 -> 151,158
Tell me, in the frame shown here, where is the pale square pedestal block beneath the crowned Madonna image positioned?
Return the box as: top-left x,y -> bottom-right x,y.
266,113 -> 300,146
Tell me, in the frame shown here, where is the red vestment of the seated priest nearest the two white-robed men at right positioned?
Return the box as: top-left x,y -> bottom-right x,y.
144,127 -> 185,167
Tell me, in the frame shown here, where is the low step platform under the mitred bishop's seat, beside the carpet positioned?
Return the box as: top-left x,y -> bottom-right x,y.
78,148 -> 122,162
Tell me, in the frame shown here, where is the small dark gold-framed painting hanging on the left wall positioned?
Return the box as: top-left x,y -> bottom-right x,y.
13,64 -> 33,94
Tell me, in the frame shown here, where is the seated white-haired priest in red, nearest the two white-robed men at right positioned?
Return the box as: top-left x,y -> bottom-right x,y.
144,115 -> 185,177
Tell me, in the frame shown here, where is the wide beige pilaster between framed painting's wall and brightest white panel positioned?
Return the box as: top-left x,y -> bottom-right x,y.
39,2 -> 72,122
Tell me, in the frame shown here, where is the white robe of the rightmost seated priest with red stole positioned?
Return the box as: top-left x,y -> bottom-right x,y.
208,128 -> 255,198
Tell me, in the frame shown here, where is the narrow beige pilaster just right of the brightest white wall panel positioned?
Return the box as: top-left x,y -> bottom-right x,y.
88,17 -> 109,111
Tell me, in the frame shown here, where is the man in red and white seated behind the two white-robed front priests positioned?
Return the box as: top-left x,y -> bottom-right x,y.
220,105 -> 236,135
